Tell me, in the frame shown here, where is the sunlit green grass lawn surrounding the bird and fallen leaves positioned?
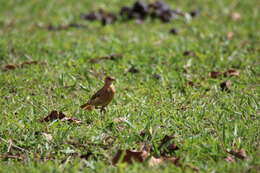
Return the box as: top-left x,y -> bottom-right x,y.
0,0 -> 260,172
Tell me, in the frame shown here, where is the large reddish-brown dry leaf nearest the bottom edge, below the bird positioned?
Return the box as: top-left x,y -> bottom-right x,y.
112,150 -> 148,165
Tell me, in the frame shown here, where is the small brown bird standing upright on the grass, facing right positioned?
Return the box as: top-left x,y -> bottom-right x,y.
80,76 -> 116,112
